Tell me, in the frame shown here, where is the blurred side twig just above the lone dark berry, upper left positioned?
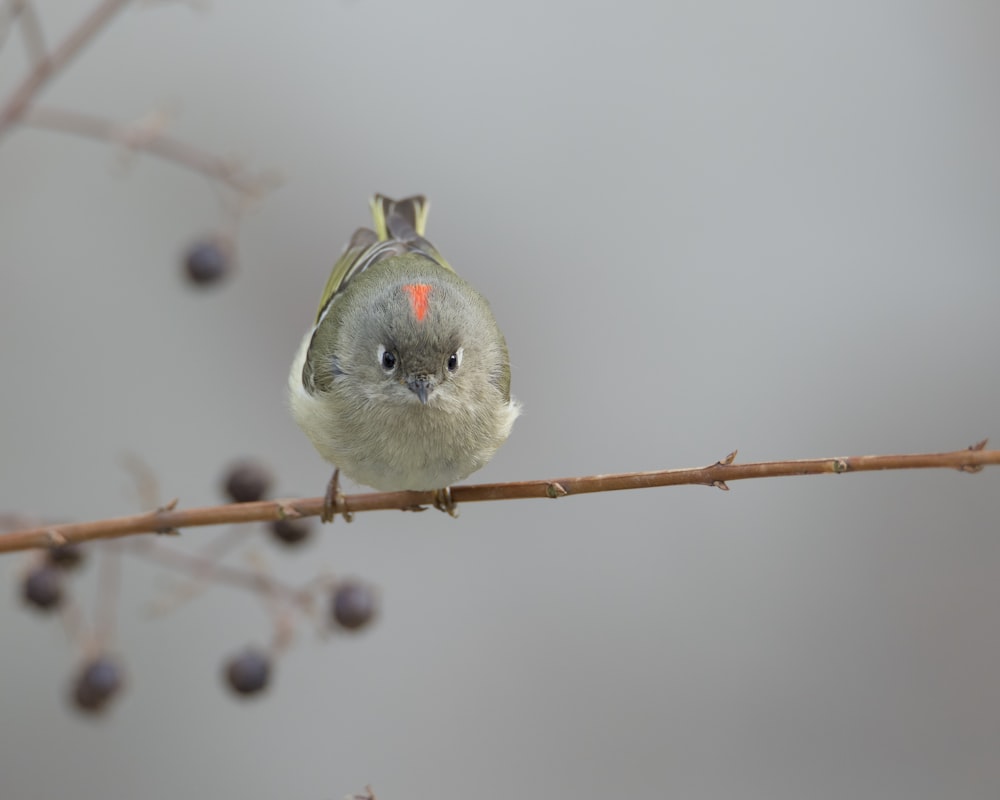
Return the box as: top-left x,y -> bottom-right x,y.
21,106 -> 278,197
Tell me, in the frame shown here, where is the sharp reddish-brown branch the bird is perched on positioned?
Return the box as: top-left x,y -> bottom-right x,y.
0,439 -> 1000,553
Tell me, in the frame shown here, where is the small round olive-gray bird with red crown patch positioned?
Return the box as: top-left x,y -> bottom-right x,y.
288,195 -> 520,521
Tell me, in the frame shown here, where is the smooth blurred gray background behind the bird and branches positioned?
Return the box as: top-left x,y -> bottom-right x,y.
0,0 -> 1000,800
